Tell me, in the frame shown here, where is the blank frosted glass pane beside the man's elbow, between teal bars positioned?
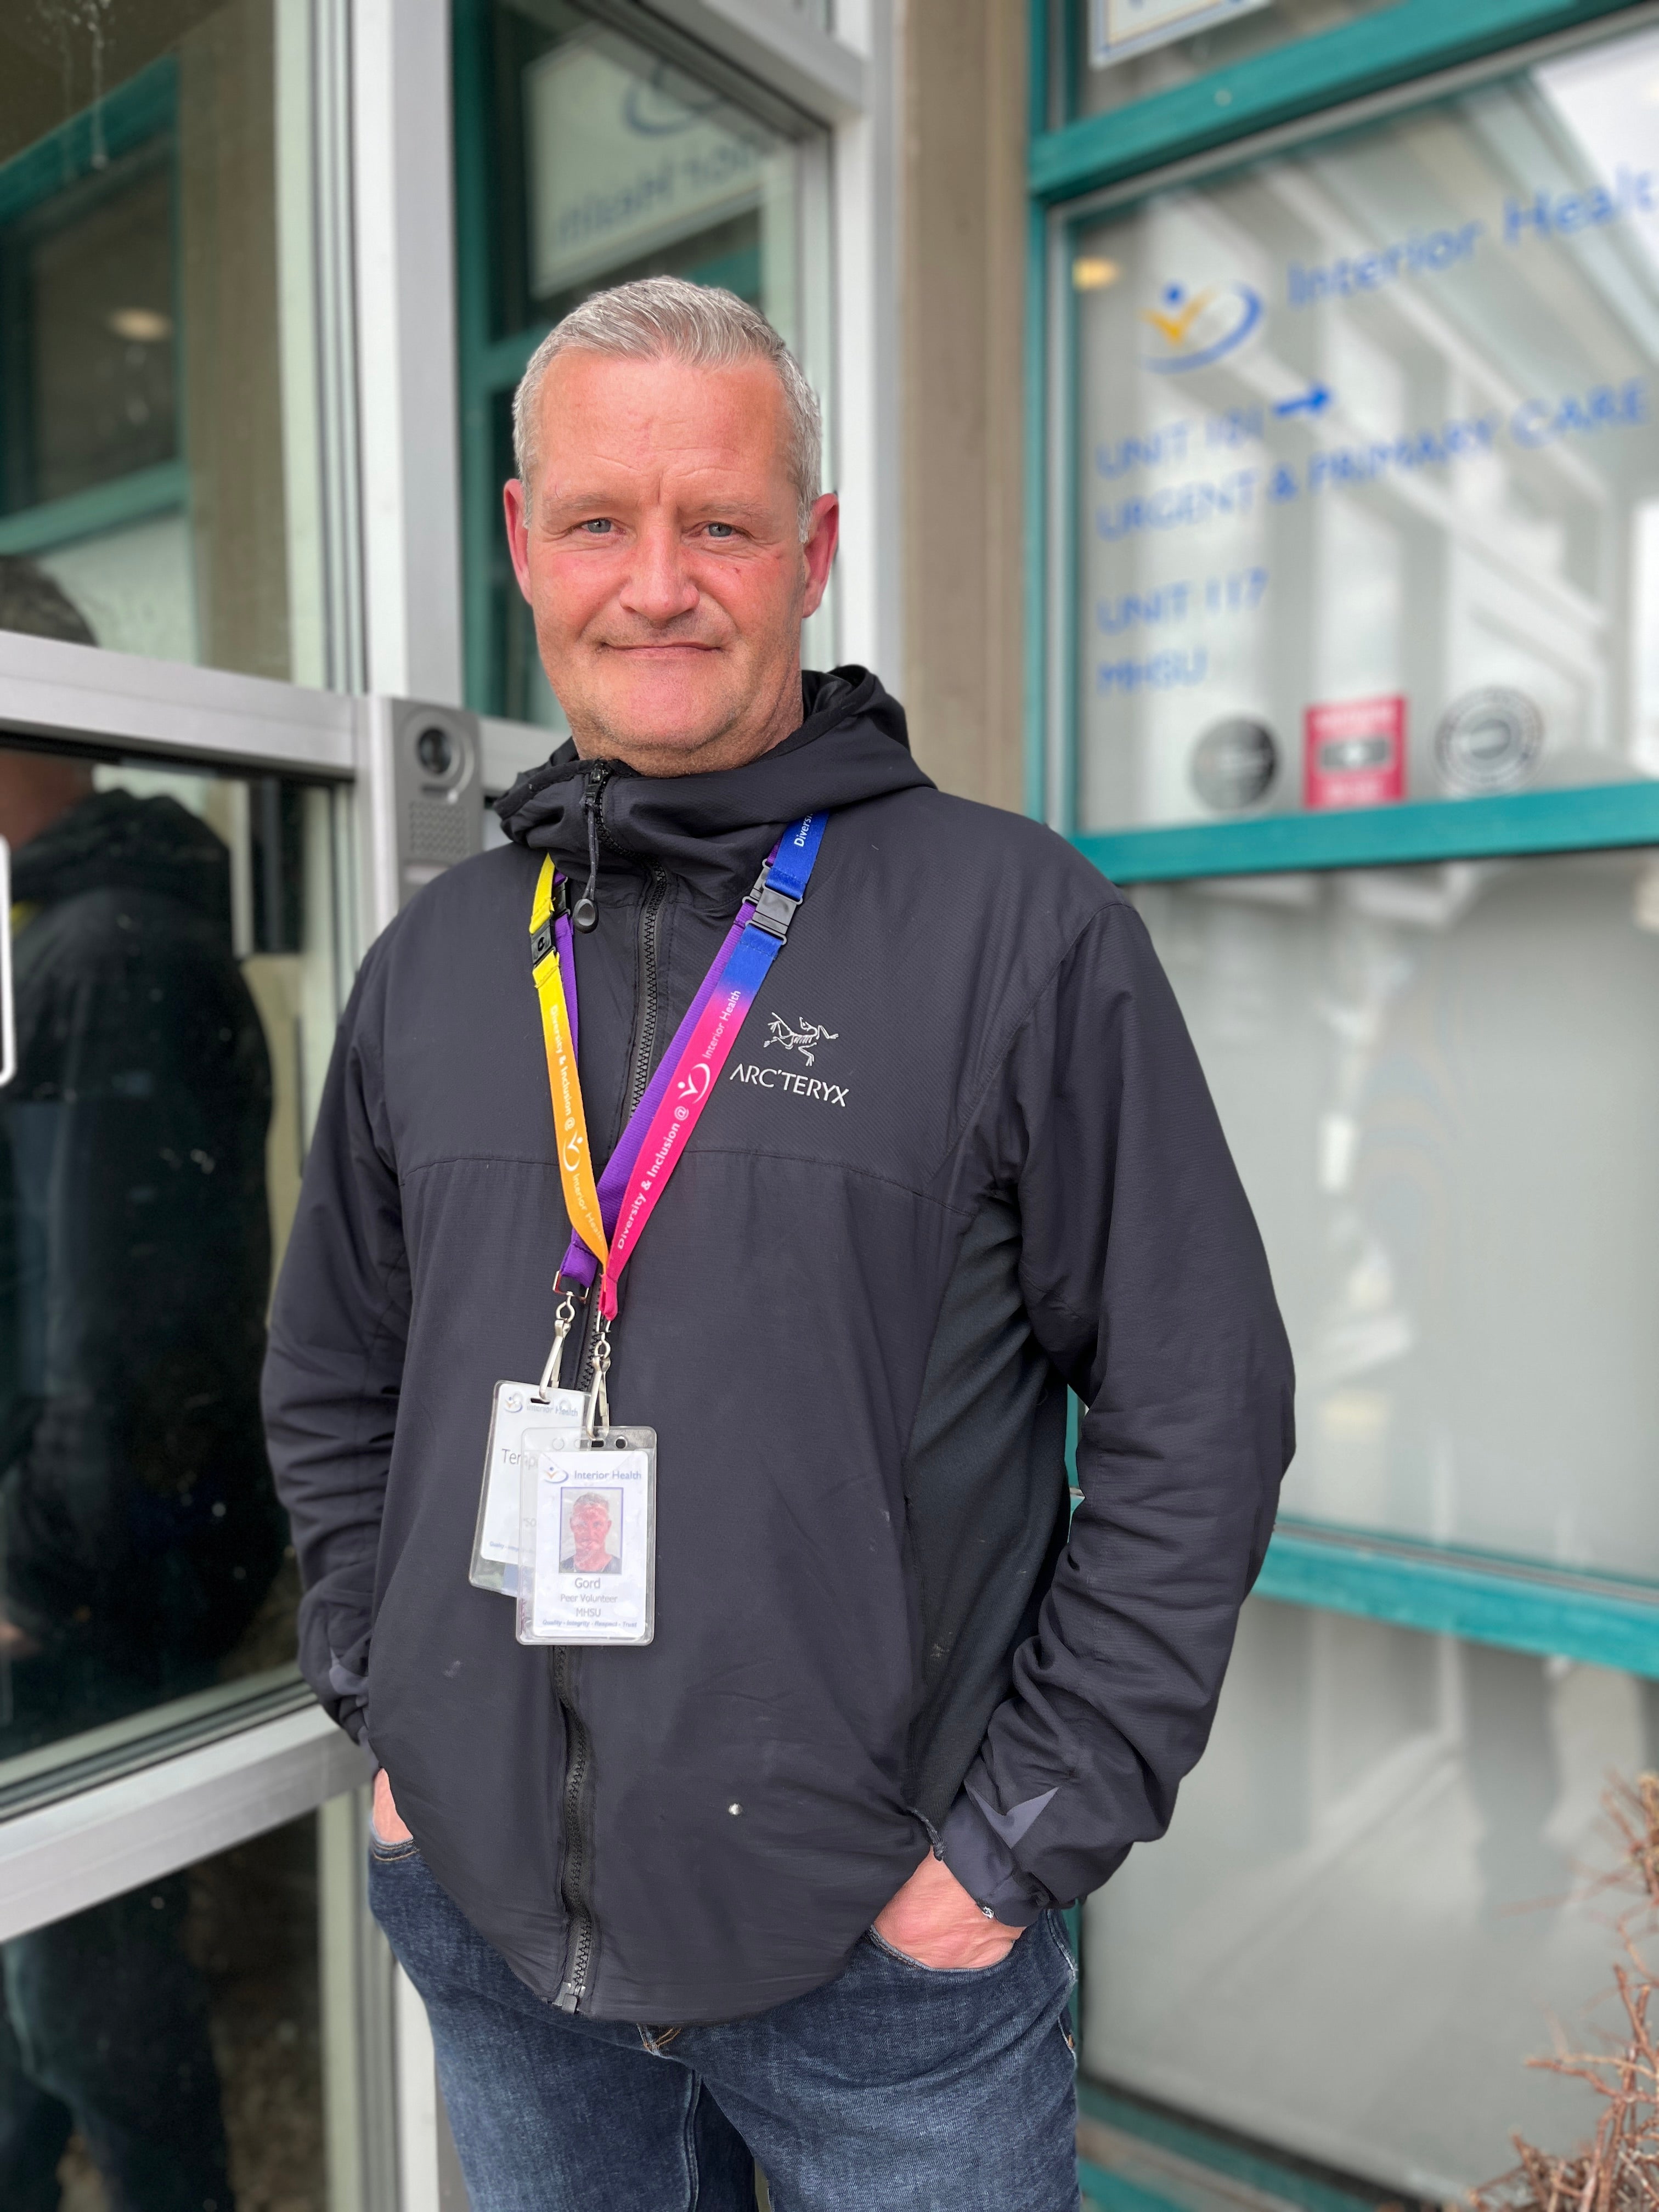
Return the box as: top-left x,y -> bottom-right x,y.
1135,851 -> 1659,1577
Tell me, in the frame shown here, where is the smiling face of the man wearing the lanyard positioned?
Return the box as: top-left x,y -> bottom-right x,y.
506,352 -> 838,776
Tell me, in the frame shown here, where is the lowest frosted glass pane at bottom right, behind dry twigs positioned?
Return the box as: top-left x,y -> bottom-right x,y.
1082,1599 -> 1659,2203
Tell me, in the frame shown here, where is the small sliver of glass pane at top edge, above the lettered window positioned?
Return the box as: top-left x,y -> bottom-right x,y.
1051,0 -> 1393,122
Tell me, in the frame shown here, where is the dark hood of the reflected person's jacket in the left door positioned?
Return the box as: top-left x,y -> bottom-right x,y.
11,792 -> 230,936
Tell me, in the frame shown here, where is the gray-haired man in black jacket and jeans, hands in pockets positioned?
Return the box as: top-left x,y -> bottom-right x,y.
266,276 -> 1292,2212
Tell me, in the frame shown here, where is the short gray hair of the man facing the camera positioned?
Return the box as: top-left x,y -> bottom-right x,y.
513,276 -> 823,540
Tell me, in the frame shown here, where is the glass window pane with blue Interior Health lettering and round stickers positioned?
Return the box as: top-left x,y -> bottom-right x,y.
1070,18 -> 1659,830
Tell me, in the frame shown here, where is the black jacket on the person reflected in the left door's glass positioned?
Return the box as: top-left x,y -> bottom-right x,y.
0,792 -> 285,1690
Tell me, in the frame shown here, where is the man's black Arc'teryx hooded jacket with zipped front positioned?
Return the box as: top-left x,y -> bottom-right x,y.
266,668 -> 1292,2022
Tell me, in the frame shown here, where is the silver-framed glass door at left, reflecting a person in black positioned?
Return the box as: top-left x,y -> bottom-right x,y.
0,0 -> 400,2212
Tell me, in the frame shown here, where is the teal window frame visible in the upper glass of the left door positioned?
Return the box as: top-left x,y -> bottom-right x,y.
0,53 -> 190,555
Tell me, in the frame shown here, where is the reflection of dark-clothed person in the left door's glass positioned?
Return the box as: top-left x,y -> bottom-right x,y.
0,560 -> 285,2212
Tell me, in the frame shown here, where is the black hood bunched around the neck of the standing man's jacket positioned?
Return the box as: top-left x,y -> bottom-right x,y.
495,668 -> 931,907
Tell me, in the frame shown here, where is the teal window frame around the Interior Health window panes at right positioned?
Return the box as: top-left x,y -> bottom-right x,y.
1040,13 -> 1659,2212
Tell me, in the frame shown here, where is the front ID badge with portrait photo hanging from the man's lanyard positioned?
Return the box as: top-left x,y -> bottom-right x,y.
517,1429 -> 657,1644
